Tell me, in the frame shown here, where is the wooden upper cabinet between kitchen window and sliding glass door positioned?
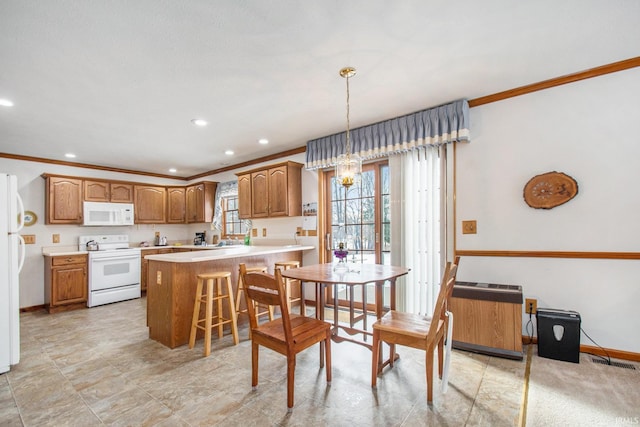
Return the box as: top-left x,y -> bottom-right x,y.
237,162 -> 303,218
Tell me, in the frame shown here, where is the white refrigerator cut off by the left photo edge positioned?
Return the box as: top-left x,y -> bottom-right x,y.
0,173 -> 25,374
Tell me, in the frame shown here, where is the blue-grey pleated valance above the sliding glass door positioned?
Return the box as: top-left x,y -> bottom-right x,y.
306,100 -> 469,169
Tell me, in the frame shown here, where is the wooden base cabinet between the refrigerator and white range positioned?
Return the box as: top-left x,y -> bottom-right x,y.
44,255 -> 89,313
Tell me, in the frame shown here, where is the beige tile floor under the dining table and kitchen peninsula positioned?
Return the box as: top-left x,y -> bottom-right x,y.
0,298 -> 526,426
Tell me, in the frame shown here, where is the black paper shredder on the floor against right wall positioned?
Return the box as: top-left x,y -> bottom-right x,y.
536,308 -> 580,363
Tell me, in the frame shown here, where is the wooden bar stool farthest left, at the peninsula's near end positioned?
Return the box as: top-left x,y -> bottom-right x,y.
189,271 -> 238,357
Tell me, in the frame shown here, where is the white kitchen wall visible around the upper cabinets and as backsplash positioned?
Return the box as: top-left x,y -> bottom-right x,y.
0,154 -> 318,308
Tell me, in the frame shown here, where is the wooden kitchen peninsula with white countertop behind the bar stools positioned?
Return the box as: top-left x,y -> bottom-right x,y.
145,245 -> 315,348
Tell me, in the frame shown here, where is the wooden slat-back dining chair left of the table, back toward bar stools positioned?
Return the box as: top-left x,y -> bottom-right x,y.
240,264 -> 331,412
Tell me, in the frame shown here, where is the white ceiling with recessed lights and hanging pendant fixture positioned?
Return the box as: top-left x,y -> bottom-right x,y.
0,0 -> 640,177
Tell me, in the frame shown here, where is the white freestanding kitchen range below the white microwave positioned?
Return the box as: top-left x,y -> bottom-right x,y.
78,234 -> 141,307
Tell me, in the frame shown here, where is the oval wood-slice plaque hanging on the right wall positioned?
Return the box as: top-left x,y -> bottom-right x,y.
524,171 -> 578,209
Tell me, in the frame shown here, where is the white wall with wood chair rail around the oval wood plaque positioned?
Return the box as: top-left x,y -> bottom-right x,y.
456,68 -> 640,352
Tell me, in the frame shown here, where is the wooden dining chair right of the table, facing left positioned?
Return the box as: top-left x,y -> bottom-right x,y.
371,257 -> 460,403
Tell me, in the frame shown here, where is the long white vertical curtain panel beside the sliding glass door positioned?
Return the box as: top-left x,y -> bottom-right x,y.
389,146 -> 446,314
